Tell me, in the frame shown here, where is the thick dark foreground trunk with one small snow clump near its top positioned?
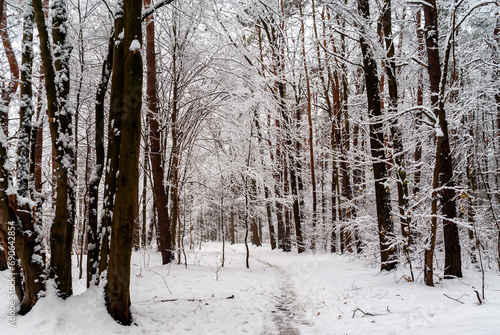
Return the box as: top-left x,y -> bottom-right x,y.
106,0 -> 143,325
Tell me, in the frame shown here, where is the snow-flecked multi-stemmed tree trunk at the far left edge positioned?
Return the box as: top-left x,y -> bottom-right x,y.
0,1 -> 45,314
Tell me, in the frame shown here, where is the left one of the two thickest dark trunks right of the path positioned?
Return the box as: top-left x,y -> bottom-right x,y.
358,0 -> 396,270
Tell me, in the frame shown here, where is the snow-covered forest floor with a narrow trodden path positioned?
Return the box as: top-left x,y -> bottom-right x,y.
0,243 -> 500,335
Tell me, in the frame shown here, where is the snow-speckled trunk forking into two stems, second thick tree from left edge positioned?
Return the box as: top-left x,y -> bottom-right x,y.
33,0 -> 75,298
